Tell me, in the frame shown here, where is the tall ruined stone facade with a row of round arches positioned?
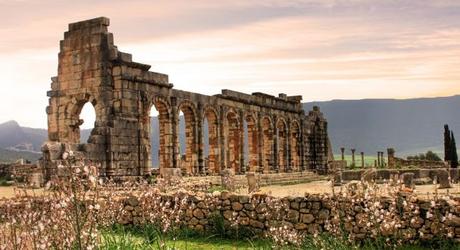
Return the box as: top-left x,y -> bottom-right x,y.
42,17 -> 330,178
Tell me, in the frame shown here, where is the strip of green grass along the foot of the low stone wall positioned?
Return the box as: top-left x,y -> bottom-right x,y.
98,225 -> 460,250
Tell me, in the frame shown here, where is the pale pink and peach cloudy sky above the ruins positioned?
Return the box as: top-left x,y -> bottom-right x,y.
0,0 -> 460,128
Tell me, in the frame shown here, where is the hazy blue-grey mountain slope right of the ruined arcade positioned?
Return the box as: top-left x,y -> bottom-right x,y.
304,96 -> 460,156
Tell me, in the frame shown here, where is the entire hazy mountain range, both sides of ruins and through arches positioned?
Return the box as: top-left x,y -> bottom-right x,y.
0,96 -> 460,163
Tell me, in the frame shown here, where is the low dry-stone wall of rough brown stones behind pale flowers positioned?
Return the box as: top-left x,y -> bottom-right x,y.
120,192 -> 460,240
